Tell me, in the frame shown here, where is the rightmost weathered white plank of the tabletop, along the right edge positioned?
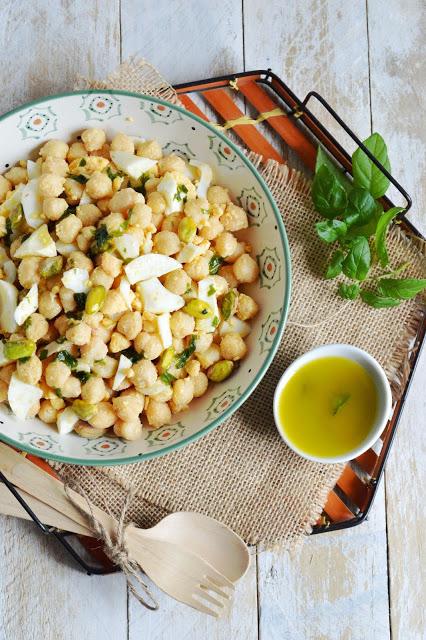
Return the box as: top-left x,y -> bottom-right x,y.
368,0 -> 426,640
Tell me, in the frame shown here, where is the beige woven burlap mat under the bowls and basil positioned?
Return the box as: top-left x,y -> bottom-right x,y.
54,62 -> 425,547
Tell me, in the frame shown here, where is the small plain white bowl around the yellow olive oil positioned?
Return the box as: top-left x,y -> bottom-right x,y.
274,344 -> 392,463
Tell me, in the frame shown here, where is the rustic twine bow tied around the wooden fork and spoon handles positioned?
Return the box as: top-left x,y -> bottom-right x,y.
65,482 -> 159,611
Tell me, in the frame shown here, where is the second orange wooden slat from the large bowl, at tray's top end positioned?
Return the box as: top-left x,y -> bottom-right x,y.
203,89 -> 284,163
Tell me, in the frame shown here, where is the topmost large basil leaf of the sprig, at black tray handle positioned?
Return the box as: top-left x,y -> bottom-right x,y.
352,133 -> 391,198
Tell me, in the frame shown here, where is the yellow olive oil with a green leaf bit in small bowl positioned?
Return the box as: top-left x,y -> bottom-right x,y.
278,357 -> 377,458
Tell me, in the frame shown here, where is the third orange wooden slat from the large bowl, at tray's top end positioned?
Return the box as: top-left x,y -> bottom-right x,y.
239,81 -> 317,169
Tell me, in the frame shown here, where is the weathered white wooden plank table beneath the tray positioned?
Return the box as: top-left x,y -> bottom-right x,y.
0,0 -> 426,640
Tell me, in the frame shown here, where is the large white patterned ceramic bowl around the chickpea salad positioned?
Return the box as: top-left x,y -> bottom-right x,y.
0,90 -> 290,465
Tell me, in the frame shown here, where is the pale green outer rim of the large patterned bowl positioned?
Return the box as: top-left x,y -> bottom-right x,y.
0,89 -> 291,467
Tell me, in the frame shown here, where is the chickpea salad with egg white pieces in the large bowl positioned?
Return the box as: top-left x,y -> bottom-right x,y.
0,129 -> 259,440
